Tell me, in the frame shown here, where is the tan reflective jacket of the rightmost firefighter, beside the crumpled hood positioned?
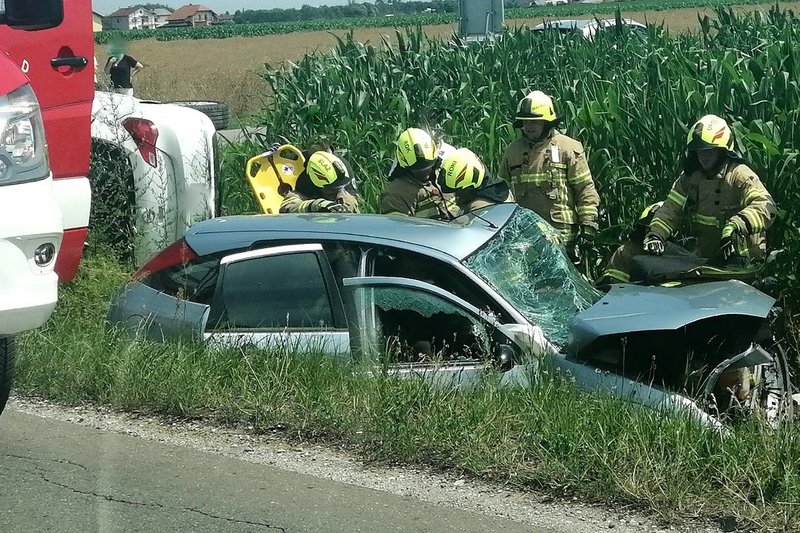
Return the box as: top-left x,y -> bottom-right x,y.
649,161 -> 775,260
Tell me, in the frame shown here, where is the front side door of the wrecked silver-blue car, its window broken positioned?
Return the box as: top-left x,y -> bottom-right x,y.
343,276 -> 530,385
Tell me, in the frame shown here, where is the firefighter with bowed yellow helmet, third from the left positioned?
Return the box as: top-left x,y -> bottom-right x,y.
437,148 -> 514,214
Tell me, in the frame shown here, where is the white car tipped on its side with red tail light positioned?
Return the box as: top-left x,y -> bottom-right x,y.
92,91 -> 216,267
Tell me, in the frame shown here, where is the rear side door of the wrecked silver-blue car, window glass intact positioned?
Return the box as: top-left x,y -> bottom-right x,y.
205,244 -> 350,356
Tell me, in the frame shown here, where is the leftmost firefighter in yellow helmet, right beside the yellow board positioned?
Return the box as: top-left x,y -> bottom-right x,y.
280,150 -> 359,213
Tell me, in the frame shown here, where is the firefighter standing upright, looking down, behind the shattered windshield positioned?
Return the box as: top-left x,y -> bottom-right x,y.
499,91 -> 600,253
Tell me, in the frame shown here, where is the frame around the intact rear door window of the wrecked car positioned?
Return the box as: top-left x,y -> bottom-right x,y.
205,243 -> 348,334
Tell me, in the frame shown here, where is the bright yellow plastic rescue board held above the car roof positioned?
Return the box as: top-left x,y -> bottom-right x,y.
245,144 -> 306,215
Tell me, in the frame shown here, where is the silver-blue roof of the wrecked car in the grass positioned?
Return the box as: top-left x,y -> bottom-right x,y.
185,204 -> 517,260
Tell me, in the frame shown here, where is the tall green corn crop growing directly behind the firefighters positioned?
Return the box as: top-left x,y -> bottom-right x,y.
250,4 -> 800,294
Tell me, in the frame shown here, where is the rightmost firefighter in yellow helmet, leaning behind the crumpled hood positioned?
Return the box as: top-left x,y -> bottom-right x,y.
644,115 -> 775,263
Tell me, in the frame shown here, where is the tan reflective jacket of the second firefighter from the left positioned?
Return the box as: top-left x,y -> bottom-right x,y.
381,172 -> 458,220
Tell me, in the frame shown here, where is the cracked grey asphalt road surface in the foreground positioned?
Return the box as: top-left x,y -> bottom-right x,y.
0,410 -> 551,533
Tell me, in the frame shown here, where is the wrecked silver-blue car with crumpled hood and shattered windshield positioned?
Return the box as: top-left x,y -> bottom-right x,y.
109,204 -> 792,426
